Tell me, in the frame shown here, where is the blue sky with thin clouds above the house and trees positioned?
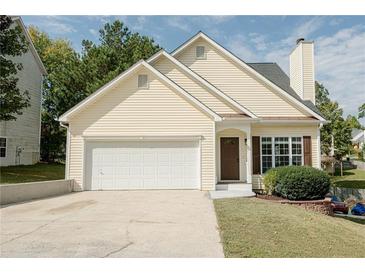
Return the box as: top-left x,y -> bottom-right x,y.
22,16 -> 365,123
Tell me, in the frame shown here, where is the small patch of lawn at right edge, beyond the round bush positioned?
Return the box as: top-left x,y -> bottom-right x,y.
332,169 -> 365,189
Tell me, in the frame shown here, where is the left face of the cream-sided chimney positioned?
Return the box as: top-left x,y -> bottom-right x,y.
289,44 -> 303,98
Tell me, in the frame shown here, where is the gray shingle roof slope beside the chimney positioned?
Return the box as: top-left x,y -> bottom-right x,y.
246,63 -> 324,118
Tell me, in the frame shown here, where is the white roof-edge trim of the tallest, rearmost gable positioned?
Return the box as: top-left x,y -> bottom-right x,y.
171,31 -> 326,122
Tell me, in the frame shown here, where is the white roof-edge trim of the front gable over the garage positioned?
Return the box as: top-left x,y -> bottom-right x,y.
58,60 -> 222,122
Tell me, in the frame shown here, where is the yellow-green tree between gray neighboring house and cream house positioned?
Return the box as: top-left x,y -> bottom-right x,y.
29,26 -> 86,161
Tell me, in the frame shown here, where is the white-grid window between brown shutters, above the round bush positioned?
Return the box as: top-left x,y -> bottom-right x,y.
261,137 -> 303,173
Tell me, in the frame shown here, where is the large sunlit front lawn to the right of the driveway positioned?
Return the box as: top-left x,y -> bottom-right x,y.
214,198 -> 365,258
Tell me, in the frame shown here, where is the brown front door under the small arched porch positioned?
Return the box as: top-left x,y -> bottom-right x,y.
221,137 -> 240,180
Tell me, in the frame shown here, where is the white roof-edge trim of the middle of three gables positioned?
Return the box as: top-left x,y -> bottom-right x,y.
147,49 -> 257,118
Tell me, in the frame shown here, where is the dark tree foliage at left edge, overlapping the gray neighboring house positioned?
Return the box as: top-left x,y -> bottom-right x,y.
0,15 -> 30,121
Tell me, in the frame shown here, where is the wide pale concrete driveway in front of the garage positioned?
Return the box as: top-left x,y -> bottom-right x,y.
0,190 -> 223,257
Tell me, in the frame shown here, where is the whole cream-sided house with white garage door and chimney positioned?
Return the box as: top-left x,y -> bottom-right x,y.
59,32 -> 325,190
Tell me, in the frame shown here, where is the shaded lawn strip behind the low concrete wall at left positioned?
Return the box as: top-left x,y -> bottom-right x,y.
0,163 -> 65,184
